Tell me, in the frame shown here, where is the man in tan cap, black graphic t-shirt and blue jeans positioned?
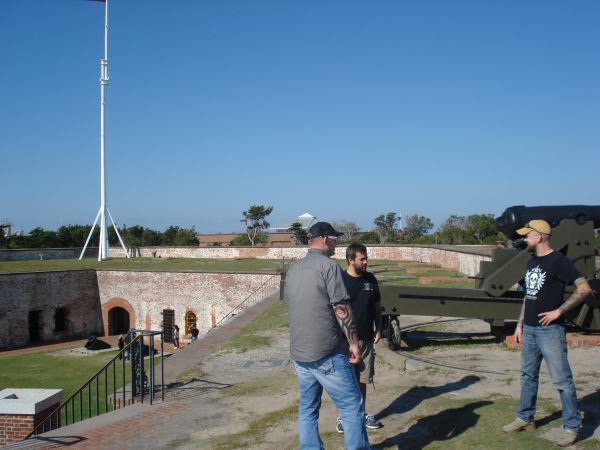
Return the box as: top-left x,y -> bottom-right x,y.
503,220 -> 592,447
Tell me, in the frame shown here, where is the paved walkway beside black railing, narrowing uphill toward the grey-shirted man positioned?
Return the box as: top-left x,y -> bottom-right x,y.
2,292 -> 279,450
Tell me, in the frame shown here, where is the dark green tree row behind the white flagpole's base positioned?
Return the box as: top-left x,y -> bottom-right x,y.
0,225 -> 198,249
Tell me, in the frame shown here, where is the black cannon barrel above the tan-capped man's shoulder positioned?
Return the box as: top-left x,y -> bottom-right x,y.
496,205 -> 600,239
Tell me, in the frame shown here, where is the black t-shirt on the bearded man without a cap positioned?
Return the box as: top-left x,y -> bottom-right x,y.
343,272 -> 381,341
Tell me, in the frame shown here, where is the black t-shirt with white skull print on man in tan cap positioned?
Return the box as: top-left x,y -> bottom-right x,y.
525,252 -> 581,327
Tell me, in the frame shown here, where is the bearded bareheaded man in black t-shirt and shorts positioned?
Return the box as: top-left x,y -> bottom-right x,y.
336,243 -> 383,433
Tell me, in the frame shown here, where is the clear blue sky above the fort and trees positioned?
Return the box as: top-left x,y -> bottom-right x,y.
0,0 -> 600,232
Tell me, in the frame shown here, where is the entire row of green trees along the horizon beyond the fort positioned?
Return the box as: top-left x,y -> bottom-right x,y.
0,205 -> 506,248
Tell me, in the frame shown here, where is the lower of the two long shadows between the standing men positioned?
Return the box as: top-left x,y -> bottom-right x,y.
373,401 -> 493,449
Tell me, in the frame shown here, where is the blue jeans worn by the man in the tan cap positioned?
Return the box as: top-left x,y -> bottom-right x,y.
517,325 -> 581,433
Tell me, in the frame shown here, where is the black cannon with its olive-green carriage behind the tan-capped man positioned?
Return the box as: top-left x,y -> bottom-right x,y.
380,205 -> 600,347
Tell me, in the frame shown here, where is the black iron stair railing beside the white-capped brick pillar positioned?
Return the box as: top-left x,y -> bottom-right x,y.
27,329 -> 165,438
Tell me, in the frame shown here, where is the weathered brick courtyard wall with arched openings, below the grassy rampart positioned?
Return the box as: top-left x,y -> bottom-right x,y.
0,270 -> 278,348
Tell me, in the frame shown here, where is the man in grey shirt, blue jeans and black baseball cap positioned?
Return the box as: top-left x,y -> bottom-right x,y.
284,222 -> 371,450
